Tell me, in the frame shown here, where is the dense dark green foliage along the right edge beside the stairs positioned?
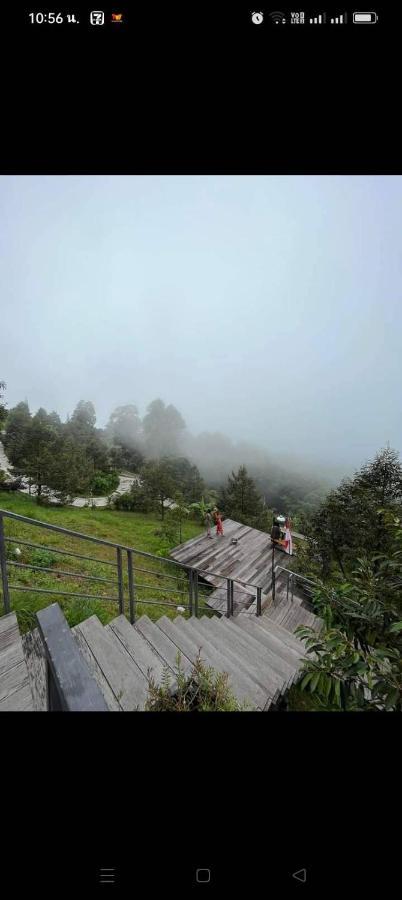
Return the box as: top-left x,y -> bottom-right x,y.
292,448 -> 402,711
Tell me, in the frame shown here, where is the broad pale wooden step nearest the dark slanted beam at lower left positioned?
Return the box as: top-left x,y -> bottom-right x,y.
74,616 -> 148,711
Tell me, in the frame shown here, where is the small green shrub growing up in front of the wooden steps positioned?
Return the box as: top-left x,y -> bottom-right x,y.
145,656 -> 246,712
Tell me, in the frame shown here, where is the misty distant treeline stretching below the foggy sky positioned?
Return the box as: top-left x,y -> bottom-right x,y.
0,385 -> 329,516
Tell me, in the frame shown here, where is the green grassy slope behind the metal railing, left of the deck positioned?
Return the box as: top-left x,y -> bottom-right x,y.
0,491 -> 202,632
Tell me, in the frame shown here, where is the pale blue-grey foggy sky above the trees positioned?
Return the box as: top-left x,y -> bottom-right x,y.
0,176 -> 402,468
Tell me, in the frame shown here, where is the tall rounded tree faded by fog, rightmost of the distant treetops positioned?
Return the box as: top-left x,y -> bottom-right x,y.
142,398 -> 186,458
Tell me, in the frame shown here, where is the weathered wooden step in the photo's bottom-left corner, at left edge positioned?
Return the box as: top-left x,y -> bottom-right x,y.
0,612 -> 35,712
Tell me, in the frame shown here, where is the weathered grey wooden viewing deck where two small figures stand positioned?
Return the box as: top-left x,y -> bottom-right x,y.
170,519 -> 290,614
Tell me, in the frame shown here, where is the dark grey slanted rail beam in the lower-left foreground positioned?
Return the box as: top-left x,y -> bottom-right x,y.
36,603 -> 107,712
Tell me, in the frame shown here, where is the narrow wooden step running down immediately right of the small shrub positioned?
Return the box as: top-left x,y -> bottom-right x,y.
182,616 -> 274,709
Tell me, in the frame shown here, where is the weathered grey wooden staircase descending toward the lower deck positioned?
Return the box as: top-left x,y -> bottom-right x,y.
0,605 -> 314,712
